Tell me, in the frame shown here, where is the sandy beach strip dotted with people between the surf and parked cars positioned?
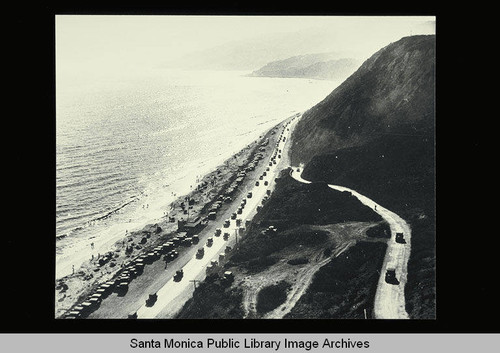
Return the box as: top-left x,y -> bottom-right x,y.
55,112 -> 300,318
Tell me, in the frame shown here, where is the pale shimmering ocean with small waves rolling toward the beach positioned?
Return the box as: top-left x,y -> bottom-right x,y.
55,69 -> 339,278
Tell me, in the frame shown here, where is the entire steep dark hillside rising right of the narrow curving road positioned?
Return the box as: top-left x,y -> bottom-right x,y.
291,36 -> 435,319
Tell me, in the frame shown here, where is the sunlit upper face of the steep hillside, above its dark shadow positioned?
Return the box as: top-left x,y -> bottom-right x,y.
291,35 -> 435,165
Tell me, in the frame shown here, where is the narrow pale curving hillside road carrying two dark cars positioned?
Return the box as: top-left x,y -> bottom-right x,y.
290,167 -> 411,319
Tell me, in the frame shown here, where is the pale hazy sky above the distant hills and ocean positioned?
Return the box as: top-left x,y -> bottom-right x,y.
56,15 -> 435,73
